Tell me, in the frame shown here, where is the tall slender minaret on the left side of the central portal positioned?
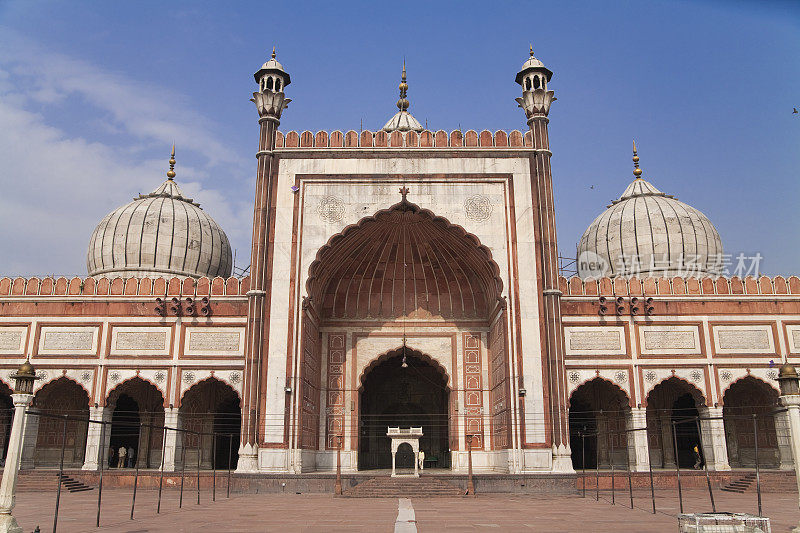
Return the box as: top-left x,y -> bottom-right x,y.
236,48 -> 291,472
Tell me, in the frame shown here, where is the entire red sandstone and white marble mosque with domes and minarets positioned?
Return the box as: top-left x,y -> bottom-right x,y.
0,46 -> 800,474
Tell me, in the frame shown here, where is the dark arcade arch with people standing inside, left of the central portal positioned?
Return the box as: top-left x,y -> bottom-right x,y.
106,377 -> 164,468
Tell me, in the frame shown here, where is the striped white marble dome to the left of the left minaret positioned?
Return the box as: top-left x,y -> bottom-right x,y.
87,179 -> 233,277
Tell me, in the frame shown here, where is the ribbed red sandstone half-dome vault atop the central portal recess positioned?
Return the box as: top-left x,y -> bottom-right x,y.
306,200 -> 503,319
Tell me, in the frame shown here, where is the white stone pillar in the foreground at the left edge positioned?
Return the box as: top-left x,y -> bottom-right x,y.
0,390 -> 34,533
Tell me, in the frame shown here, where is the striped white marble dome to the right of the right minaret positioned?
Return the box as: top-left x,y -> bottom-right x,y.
577,178 -> 722,278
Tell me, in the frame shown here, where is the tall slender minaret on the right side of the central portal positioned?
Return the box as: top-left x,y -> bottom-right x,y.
516,46 -> 573,472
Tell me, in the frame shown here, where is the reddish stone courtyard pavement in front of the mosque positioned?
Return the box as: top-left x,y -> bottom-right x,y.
14,489 -> 800,533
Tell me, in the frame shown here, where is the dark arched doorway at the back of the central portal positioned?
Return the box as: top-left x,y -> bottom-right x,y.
358,348 -> 450,470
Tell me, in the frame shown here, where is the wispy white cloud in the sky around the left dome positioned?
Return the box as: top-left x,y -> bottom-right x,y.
0,28 -> 250,275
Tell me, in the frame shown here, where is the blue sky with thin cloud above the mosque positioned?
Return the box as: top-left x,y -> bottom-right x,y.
0,0 -> 800,275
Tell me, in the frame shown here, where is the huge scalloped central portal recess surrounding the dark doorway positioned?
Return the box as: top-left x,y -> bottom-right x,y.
304,198 -> 504,469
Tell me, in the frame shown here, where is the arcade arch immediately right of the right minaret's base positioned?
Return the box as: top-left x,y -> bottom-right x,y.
569,378 -> 630,470
